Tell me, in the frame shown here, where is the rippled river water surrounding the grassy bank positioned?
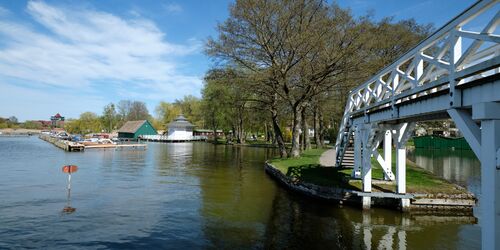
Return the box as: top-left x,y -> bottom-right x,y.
0,137 -> 480,249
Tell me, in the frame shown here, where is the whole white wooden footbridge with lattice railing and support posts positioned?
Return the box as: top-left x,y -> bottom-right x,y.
335,0 -> 500,249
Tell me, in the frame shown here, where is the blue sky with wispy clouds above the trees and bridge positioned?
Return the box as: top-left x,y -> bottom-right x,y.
0,0 -> 475,121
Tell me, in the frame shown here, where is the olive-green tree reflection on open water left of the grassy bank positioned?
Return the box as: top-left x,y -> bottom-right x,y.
193,146 -> 276,249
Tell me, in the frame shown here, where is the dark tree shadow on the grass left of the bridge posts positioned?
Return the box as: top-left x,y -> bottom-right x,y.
286,164 -> 359,190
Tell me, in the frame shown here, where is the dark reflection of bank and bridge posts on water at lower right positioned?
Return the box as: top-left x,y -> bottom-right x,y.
265,190 -> 479,249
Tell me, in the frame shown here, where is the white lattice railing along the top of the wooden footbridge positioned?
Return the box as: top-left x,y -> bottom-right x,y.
335,0 -> 500,167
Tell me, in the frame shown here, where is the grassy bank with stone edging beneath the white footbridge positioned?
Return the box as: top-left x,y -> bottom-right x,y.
270,149 -> 463,194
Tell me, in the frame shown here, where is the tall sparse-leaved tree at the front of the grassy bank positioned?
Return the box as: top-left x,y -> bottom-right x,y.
207,0 -> 363,157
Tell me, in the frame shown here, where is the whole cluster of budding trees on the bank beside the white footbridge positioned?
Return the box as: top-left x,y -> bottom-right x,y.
203,0 -> 432,158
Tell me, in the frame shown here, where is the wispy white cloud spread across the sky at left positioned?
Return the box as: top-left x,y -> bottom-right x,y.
0,1 -> 201,107
